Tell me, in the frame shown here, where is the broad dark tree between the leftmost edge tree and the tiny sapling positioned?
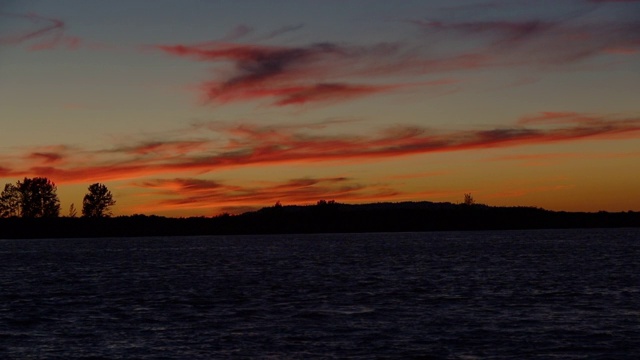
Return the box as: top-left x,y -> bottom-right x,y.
17,177 -> 60,218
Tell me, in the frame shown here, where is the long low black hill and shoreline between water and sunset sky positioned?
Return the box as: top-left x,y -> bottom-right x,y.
0,202 -> 640,239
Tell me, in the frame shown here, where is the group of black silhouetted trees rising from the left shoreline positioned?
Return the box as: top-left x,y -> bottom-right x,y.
0,177 -> 116,218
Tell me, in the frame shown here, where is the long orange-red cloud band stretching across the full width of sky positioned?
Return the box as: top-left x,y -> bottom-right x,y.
3,113 -> 640,183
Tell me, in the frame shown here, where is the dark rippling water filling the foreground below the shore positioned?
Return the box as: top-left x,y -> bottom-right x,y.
0,229 -> 640,359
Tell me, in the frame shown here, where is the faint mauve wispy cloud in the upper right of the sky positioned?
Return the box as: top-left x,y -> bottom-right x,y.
411,19 -> 640,66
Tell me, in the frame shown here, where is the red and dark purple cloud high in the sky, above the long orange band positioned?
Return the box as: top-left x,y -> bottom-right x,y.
156,43 -> 458,106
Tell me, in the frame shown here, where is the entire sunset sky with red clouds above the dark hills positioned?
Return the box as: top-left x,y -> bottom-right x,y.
0,0 -> 640,217
